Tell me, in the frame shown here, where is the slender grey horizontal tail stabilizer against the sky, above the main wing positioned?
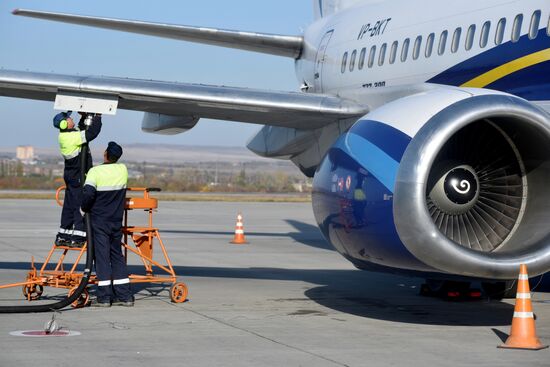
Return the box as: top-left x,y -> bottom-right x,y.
13,9 -> 303,59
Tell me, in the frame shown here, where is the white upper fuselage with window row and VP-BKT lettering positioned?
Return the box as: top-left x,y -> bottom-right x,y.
296,0 -> 550,112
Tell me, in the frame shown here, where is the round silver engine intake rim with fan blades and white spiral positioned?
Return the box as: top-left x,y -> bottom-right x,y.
393,94 -> 550,279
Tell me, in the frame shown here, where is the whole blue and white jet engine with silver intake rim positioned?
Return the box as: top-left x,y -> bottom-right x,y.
313,88 -> 550,279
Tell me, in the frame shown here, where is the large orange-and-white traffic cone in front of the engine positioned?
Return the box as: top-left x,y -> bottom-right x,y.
499,264 -> 548,350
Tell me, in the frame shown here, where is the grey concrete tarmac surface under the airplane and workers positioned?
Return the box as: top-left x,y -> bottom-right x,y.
0,200 -> 550,367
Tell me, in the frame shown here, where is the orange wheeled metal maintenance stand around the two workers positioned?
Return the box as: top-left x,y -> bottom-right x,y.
0,187 -> 188,307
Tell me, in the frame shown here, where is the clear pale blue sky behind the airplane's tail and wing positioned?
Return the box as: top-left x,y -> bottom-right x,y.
0,0 -> 313,147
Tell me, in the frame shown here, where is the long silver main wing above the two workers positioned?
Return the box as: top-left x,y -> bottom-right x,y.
0,69 -> 368,130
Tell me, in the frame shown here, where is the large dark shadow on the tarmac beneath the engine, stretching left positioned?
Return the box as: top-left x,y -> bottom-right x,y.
0,262 -> 532,326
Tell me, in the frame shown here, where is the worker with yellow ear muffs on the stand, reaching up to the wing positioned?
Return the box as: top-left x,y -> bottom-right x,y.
53,111 -> 102,247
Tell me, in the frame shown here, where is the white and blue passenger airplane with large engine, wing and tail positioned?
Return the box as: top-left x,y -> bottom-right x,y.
0,0 -> 550,298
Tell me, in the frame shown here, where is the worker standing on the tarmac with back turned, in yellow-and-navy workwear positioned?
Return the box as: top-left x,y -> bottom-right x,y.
82,142 -> 134,307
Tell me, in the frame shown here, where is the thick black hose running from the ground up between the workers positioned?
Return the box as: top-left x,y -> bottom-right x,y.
0,117 -> 94,313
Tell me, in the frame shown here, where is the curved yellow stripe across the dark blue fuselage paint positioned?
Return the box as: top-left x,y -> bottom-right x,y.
461,48 -> 550,88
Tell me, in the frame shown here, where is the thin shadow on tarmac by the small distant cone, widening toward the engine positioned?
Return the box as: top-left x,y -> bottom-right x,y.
161,219 -> 335,251
